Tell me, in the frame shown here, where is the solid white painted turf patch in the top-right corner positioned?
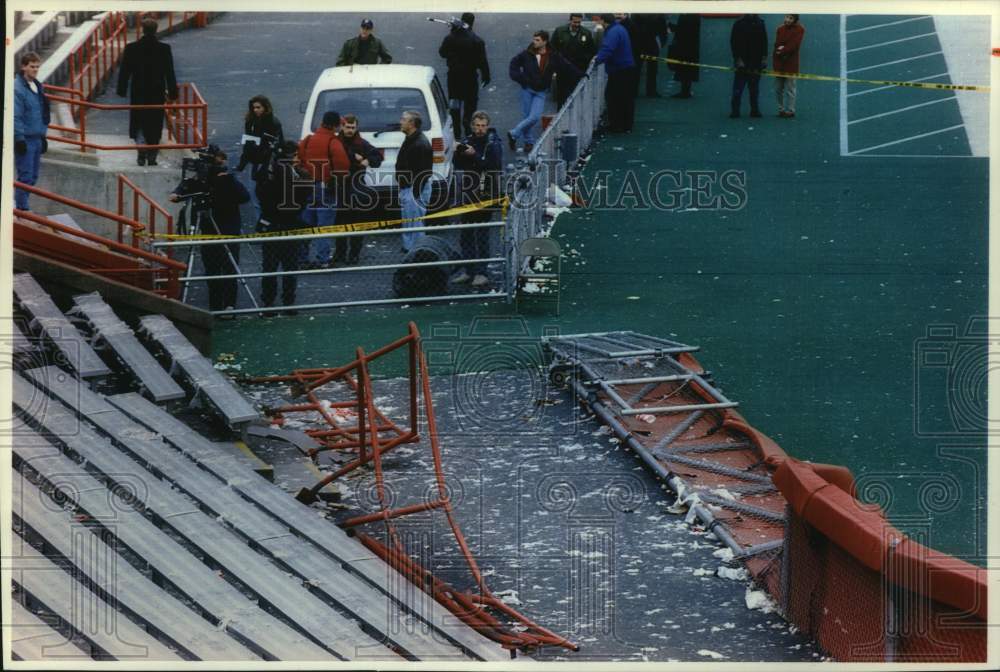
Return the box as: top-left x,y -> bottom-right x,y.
934,16 -> 990,156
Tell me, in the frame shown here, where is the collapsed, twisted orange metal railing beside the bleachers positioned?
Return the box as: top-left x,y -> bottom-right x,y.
250,322 -> 579,651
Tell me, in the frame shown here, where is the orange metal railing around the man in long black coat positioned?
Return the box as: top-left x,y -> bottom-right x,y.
45,82 -> 208,152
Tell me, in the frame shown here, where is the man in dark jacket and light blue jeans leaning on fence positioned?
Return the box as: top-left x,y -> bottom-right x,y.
507,30 -> 584,152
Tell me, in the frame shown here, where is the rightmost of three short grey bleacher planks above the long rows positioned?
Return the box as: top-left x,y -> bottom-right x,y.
140,315 -> 260,427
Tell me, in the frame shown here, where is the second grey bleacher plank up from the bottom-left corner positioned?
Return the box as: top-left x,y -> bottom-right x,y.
10,532 -> 182,661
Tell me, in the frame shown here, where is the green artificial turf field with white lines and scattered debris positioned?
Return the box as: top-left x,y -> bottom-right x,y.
215,15 -> 988,562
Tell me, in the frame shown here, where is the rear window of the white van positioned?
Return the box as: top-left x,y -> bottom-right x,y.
310,88 -> 432,132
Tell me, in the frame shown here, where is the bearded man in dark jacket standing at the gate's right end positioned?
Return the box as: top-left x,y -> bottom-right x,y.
451,110 -> 503,287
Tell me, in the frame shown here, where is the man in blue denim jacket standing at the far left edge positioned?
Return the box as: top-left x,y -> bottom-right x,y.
14,51 -> 49,210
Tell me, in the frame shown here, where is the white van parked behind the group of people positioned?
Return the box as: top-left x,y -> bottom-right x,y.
302,64 -> 455,205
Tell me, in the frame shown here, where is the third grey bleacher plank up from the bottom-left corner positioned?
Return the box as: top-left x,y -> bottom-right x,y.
11,477 -> 260,660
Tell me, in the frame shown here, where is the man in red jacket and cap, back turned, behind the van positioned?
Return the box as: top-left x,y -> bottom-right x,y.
299,111 -> 351,268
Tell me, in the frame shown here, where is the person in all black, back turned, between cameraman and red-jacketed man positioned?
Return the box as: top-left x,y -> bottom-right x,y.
257,141 -> 312,315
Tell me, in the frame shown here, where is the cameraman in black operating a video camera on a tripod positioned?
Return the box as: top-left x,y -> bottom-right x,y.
169,145 -> 250,319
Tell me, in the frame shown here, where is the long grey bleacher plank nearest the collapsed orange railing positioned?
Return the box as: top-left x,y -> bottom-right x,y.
108,386 -> 510,661
